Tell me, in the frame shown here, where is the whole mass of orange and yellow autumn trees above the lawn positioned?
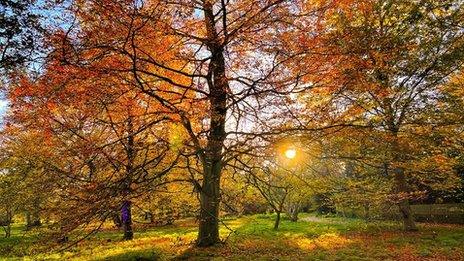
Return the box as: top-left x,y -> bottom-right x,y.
1,0 -> 464,249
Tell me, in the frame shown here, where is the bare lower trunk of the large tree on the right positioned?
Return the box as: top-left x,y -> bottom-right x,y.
394,168 -> 417,231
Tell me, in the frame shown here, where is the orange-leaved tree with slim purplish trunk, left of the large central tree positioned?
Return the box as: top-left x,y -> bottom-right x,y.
10,36 -> 179,239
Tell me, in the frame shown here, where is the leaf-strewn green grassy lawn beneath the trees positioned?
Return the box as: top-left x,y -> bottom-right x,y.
0,214 -> 464,260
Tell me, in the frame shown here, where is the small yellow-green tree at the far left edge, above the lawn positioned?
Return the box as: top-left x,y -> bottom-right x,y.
0,127 -> 56,237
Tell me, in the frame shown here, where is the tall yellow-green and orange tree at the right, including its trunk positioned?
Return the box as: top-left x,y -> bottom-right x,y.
300,0 -> 464,230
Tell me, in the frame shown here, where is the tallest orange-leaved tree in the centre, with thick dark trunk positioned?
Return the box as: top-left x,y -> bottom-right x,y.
41,0 -> 326,246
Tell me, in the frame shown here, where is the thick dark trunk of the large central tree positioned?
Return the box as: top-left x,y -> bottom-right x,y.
197,1 -> 228,247
